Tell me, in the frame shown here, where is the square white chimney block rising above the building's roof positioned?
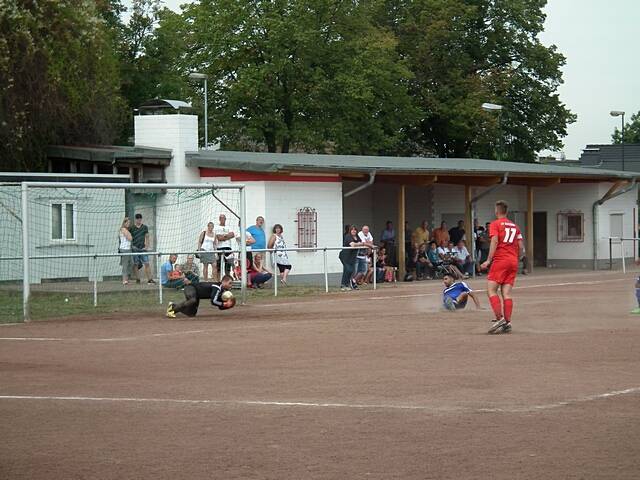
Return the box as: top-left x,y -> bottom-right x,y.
134,114 -> 200,183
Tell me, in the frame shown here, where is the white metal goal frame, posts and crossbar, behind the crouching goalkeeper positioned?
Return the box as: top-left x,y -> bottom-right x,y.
20,181 -> 247,322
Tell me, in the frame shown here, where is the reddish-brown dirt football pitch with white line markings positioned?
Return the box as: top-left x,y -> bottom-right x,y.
0,273 -> 640,480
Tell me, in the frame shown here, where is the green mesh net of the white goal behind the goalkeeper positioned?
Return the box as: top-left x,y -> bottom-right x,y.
0,182 -> 246,322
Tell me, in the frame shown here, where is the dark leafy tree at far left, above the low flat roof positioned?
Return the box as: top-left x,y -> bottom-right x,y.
0,0 -> 123,171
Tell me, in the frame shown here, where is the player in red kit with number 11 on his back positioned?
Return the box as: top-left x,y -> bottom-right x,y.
480,200 -> 523,333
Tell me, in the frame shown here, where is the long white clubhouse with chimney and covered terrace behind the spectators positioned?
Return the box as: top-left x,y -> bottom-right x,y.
0,114 -> 638,282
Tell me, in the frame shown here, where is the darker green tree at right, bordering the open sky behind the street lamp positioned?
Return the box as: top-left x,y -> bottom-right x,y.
377,0 -> 575,161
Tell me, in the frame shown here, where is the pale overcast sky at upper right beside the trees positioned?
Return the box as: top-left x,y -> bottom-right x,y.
129,0 -> 640,159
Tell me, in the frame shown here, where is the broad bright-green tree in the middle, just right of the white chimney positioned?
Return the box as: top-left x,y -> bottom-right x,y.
180,0 -> 417,153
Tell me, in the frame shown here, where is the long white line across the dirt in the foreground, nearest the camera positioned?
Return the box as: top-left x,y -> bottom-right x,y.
0,387 -> 640,413
